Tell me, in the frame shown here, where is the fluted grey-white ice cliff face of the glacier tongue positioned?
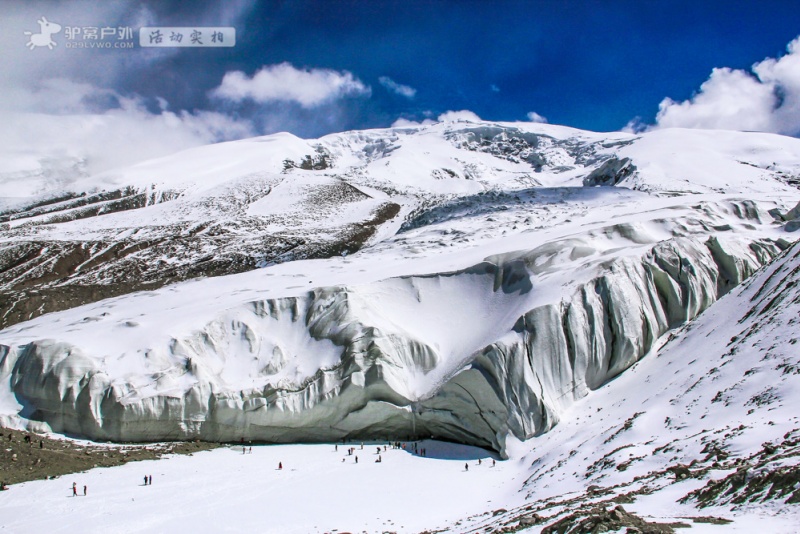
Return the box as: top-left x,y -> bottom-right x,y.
0,233 -> 780,451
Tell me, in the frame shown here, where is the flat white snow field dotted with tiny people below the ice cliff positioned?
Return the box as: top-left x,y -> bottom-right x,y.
0,441 -> 520,534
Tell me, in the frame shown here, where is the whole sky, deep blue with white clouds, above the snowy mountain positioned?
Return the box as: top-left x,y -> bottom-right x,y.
0,0 -> 800,171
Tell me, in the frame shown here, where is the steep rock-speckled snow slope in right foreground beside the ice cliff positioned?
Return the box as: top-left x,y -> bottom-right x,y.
462,228 -> 800,533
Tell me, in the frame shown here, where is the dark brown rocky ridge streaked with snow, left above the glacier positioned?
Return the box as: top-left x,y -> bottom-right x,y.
0,182 -> 400,328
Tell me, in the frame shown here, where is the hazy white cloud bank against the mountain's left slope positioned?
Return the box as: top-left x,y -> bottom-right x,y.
0,80 -> 256,196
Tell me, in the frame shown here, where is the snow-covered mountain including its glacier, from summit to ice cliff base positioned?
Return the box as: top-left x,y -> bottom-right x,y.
0,122 -> 800,452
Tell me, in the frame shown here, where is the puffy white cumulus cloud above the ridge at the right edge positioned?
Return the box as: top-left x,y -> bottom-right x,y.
656,37 -> 800,135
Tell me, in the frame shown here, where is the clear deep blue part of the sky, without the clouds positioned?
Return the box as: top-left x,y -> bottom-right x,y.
115,0 -> 800,135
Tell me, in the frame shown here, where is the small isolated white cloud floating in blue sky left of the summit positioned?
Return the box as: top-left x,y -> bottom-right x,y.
211,63 -> 371,108
